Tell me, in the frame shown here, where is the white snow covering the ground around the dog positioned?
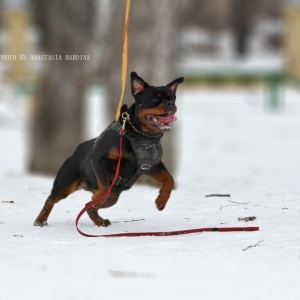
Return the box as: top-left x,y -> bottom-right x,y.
0,88 -> 300,300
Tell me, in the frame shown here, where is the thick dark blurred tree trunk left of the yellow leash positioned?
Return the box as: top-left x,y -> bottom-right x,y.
29,0 -> 94,174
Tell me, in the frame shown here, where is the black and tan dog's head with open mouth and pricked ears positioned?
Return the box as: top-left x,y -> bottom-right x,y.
131,72 -> 184,134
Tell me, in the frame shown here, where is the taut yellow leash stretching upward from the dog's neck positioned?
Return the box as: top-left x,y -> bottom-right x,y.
116,0 -> 130,120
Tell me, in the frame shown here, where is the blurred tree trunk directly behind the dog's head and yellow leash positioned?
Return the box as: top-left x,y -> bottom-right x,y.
108,0 -> 180,172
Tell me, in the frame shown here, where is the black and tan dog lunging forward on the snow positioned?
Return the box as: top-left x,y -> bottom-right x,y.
34,72 -> 183,226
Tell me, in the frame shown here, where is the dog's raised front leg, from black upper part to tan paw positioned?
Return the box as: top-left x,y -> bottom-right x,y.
147,162 -> 174,210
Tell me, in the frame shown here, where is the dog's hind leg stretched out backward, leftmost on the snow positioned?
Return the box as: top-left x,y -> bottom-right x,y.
33,157 -> 82,227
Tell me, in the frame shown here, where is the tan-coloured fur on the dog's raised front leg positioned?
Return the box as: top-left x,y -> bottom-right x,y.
150,170 -> 174,210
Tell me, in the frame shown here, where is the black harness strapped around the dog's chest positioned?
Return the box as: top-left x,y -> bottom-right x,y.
108,122 -> 162,187
